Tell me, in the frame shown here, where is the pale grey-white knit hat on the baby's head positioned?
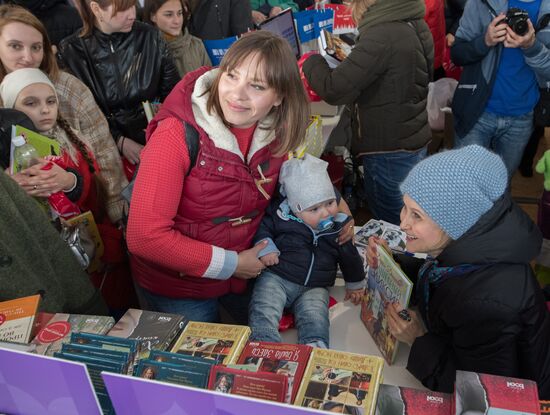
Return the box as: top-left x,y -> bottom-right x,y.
279,154 -> 336,213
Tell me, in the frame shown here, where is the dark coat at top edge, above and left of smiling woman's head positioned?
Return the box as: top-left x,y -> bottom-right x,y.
187,0 -> 254,40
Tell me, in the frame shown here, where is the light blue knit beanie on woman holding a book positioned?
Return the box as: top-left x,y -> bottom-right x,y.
401,145 -> 508,239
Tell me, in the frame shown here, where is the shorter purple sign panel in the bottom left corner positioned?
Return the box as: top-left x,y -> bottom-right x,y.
0,349 -> 101,415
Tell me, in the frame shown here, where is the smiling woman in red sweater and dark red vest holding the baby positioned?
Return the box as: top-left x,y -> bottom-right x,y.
127,31 -> 352,322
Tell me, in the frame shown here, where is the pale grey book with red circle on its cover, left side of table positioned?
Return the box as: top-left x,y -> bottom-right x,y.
30,313 -> 115,356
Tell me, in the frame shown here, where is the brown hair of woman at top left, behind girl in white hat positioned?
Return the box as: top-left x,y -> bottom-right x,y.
0,4 -> 59,82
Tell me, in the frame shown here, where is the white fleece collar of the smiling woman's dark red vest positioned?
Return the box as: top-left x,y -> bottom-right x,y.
191,68 -> 275,161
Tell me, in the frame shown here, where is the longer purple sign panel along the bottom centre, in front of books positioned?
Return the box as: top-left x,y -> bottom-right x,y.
101,372 -> 326,415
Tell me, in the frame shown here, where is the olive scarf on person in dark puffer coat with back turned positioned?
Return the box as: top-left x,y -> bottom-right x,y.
359,0 -> 426,32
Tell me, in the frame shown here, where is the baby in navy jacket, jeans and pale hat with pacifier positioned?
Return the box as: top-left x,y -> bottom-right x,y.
249,154 -> 365,348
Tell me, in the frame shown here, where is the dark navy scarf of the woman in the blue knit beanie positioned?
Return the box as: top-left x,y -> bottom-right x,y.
416,259 -> 491,330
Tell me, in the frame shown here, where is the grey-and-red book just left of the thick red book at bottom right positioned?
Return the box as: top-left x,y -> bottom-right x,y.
376,385 -> 453,415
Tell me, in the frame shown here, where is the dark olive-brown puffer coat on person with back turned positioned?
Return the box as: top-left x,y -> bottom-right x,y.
303,2 -> 433,154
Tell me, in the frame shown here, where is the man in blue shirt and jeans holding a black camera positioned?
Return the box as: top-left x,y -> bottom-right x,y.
451,0 -> 550,179
